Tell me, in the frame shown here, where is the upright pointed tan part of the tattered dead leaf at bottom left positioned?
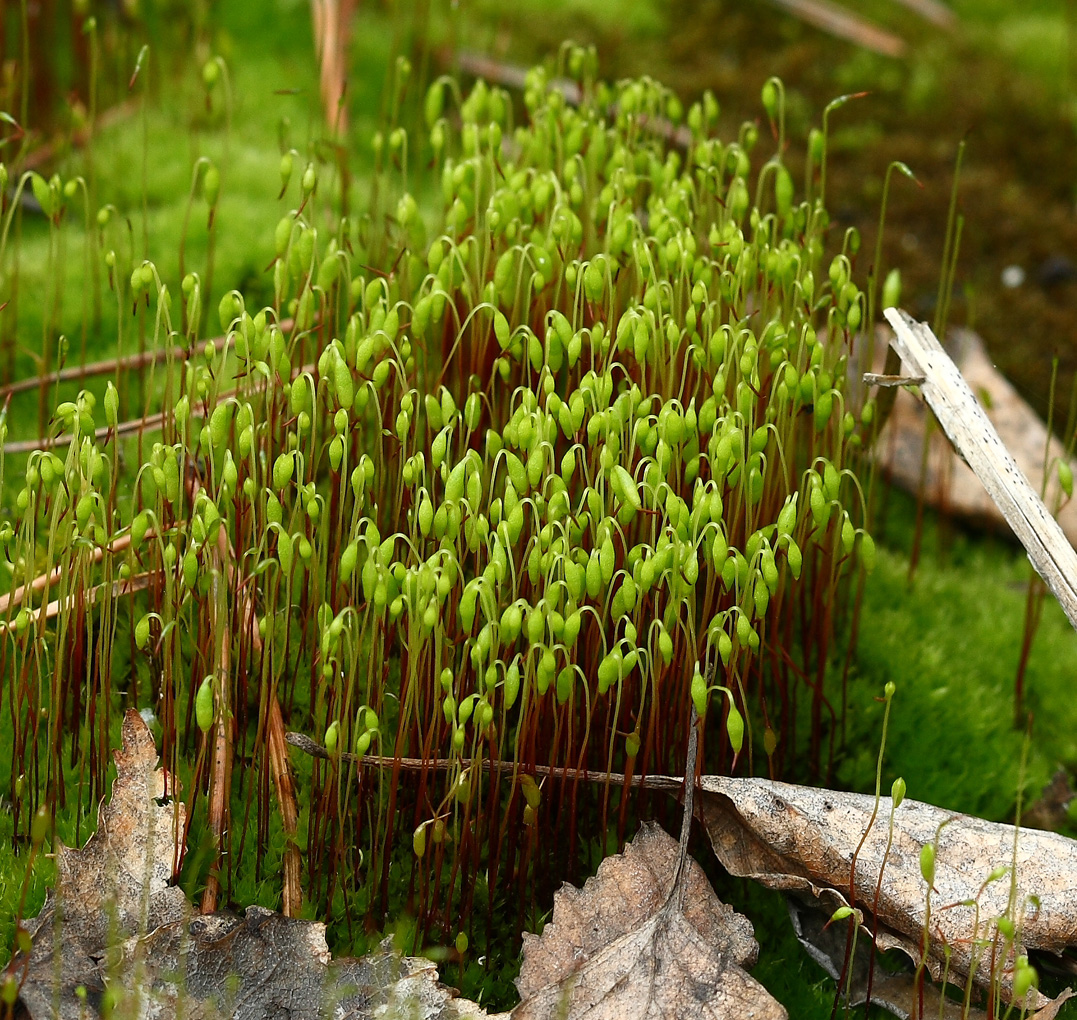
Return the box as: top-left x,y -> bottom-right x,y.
9,711 -> 186,1020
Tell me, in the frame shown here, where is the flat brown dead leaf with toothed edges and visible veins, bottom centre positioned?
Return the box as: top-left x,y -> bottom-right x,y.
512,825 -> 787,1020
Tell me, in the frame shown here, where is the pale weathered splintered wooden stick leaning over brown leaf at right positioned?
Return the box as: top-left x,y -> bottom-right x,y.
883,308 -> 1077,628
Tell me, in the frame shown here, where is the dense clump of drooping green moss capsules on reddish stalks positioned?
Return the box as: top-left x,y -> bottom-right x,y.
0,48 -> 873,990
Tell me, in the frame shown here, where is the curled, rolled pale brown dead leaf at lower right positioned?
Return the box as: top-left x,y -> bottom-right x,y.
689,777 -> 1077,1016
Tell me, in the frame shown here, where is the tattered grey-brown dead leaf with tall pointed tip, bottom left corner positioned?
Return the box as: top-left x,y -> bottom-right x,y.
5,711 -> 501,1020
